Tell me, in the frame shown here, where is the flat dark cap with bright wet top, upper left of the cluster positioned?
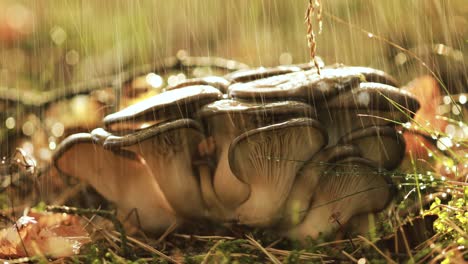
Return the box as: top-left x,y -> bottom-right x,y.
104,85 -> 222,131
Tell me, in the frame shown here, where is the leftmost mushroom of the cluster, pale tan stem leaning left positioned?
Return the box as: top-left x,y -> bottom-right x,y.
53,133 -> 178,232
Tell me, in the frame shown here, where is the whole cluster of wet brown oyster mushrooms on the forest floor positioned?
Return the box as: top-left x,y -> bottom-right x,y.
53,65 -> 419,239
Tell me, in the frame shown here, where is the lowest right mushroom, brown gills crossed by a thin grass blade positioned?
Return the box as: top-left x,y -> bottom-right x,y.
288,157 -> 393,240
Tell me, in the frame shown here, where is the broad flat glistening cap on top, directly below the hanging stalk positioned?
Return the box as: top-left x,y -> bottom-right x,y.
229,68 -> 364,104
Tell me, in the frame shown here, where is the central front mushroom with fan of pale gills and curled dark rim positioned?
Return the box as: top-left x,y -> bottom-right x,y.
228,118 -> 327,226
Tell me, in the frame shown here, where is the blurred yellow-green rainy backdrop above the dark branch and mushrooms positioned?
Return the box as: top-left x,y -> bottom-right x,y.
0,0 -> 468,90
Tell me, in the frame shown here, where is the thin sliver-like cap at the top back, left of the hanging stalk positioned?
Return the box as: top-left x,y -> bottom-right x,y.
224,65 -> 302,83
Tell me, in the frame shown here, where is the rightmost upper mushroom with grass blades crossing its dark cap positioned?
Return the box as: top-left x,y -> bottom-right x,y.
317,83 -> 419,145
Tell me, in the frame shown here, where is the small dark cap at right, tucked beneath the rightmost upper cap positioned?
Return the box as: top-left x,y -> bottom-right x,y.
338,126 -> 405,170
